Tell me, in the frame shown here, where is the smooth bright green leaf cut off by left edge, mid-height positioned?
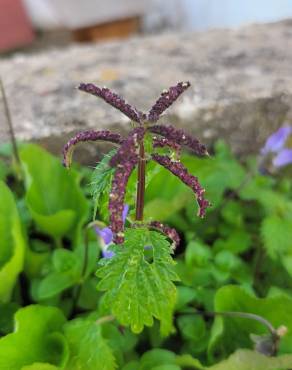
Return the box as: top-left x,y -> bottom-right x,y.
0,181 -> 26,302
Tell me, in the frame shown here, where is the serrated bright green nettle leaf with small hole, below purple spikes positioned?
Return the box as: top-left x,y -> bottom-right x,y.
97,229 -> 177,334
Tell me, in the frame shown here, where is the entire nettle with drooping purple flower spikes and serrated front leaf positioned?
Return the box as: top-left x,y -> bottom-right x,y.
63,82 -> 210,334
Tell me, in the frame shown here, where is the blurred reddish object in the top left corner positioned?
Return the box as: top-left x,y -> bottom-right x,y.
0,0 -> 34,51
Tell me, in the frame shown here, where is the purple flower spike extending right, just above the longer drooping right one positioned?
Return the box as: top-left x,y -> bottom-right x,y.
148,125 -> 208,156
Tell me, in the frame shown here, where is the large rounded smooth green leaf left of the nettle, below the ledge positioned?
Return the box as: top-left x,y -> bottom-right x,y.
20,144 -> 88,243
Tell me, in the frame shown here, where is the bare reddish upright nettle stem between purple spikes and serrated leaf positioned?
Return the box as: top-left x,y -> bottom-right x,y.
136,141 -> 146,221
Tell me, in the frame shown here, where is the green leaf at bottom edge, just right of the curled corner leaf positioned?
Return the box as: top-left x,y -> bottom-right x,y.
64,319 -> 117,370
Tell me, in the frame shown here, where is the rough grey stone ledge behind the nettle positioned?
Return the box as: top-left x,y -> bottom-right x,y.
0,20 -> 292,160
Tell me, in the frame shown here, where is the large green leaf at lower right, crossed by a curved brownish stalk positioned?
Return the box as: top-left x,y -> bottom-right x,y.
209,286 -> 292,355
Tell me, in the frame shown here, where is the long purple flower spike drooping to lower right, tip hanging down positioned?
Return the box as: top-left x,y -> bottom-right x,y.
152,154 -> 210,217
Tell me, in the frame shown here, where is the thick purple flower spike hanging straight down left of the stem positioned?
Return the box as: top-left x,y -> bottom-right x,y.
109,156 -> 138,244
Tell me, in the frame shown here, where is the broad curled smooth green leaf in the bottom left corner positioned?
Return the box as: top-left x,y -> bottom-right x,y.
0,305 -> 68,370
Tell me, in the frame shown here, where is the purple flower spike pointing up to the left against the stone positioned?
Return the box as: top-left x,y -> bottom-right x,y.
78,83 -> 143,123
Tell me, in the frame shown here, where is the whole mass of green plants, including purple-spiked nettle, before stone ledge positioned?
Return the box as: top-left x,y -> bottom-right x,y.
0,83 -> 292,370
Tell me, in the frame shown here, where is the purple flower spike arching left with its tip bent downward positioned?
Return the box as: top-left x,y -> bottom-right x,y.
63,130 -> 124,168
